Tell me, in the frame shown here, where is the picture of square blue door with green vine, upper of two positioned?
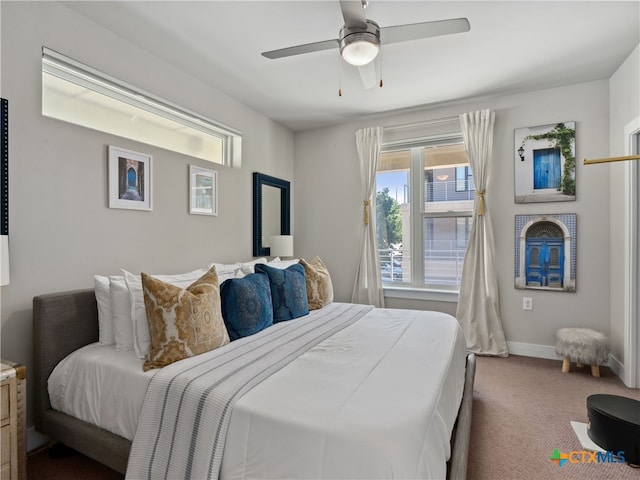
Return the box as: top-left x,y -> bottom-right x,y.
514,122 -> 576,203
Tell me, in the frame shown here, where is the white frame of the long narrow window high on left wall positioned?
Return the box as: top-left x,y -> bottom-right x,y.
42,47 -> 242,168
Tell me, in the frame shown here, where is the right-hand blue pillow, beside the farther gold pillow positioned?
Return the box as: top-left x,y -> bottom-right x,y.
255,263 -> 309,323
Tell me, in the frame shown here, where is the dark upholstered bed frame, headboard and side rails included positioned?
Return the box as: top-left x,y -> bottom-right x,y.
33,289 -> 476,480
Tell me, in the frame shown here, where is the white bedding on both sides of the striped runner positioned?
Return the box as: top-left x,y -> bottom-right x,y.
50,309 -> 466,479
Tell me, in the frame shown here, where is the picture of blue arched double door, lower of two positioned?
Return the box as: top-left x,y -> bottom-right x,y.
514,213 -> 577,292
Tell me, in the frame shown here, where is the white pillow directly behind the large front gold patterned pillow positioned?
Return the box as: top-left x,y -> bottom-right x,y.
122,268 -> 207,359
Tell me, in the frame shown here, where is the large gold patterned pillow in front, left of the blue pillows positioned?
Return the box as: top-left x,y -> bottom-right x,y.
142,267 -> 229,372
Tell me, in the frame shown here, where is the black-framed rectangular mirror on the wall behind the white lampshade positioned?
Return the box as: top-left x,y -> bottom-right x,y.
253,172 -> 291,257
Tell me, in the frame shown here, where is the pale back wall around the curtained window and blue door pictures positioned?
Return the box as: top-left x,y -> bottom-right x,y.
295,80 -> 610,353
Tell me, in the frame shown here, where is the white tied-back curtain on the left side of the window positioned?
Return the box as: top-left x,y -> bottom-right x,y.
351,127 -> 384,307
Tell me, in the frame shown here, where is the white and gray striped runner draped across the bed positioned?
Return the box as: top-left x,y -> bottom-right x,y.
126,303 -> 373,480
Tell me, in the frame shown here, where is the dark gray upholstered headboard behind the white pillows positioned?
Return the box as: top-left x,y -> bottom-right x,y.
33,289 -> 98,432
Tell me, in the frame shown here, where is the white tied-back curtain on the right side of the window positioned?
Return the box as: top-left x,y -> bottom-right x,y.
456,110 -> 509,357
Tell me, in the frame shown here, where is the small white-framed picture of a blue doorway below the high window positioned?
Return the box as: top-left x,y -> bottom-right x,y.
109,145 -> 151,211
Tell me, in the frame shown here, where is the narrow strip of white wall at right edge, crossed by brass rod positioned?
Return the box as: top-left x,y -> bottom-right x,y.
608,45 -> 640,384
